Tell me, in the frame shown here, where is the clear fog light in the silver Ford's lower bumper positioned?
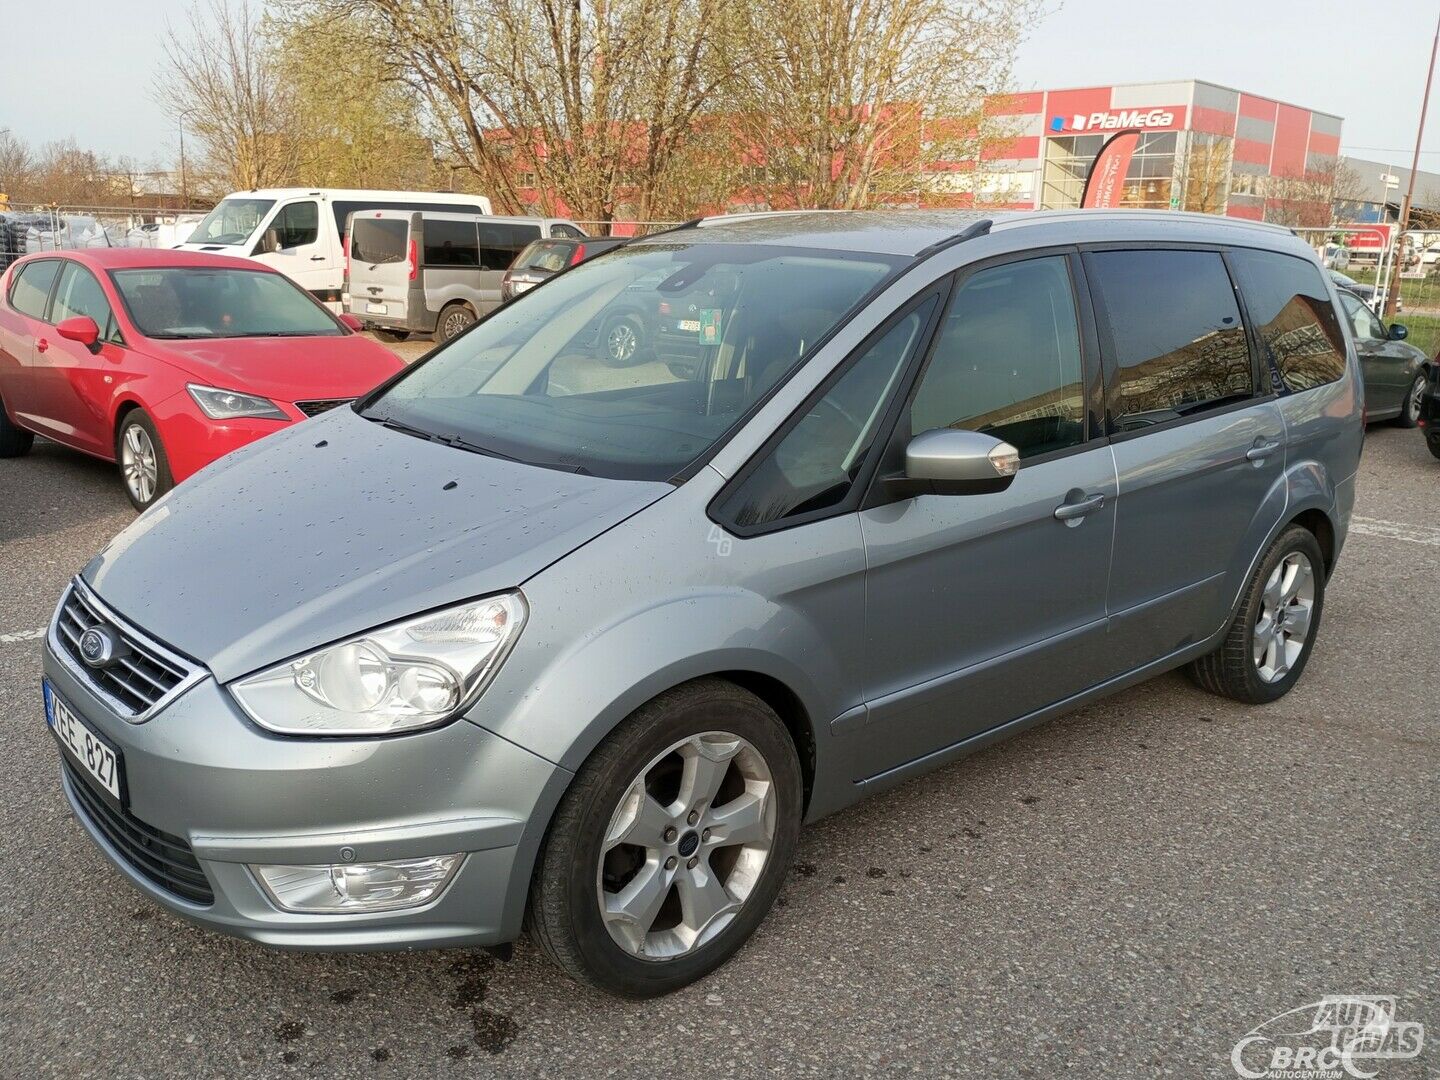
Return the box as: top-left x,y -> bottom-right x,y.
251,855 -> 464,914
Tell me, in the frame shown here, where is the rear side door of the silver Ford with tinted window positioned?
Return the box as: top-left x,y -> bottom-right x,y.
1084,248 -> 1286,672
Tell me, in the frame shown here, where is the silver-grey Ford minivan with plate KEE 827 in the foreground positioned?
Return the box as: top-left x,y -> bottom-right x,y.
33,210 -> 1364,996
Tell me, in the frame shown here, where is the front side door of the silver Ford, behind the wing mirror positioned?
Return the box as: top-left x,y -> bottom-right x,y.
854,255 -> 1116,779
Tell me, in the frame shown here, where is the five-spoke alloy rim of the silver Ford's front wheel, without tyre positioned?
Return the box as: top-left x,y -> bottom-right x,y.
595,732 -> 776,960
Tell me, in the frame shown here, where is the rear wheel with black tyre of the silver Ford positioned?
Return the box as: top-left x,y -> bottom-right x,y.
1188,526 -> 1325,704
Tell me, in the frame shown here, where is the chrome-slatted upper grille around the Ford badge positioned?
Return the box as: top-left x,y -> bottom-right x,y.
55,579 -> 196,720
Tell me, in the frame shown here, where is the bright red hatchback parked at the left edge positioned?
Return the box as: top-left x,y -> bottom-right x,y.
0,248 -> 403,510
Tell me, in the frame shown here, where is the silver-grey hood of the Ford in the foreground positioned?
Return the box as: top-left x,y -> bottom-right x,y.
84,409 -> 672,681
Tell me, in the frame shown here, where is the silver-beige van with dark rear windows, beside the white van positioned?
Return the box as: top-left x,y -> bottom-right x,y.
346,210 -> 585,341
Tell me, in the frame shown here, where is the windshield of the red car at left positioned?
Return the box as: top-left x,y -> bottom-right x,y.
112,266 -> 343,338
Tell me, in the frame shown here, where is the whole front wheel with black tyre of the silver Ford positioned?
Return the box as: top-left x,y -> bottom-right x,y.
528,678 -> 802,998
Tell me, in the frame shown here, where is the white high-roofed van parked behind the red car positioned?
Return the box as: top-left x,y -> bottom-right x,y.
176,187 -> 491,312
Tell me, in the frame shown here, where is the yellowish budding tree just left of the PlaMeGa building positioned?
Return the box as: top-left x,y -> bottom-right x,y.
732,0 -> 1038,209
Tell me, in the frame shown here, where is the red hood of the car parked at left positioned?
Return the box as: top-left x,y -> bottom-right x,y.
150,334 -> 405,402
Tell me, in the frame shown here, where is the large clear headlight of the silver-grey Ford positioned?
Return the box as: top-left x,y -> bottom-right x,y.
230,592 -> 526,734
